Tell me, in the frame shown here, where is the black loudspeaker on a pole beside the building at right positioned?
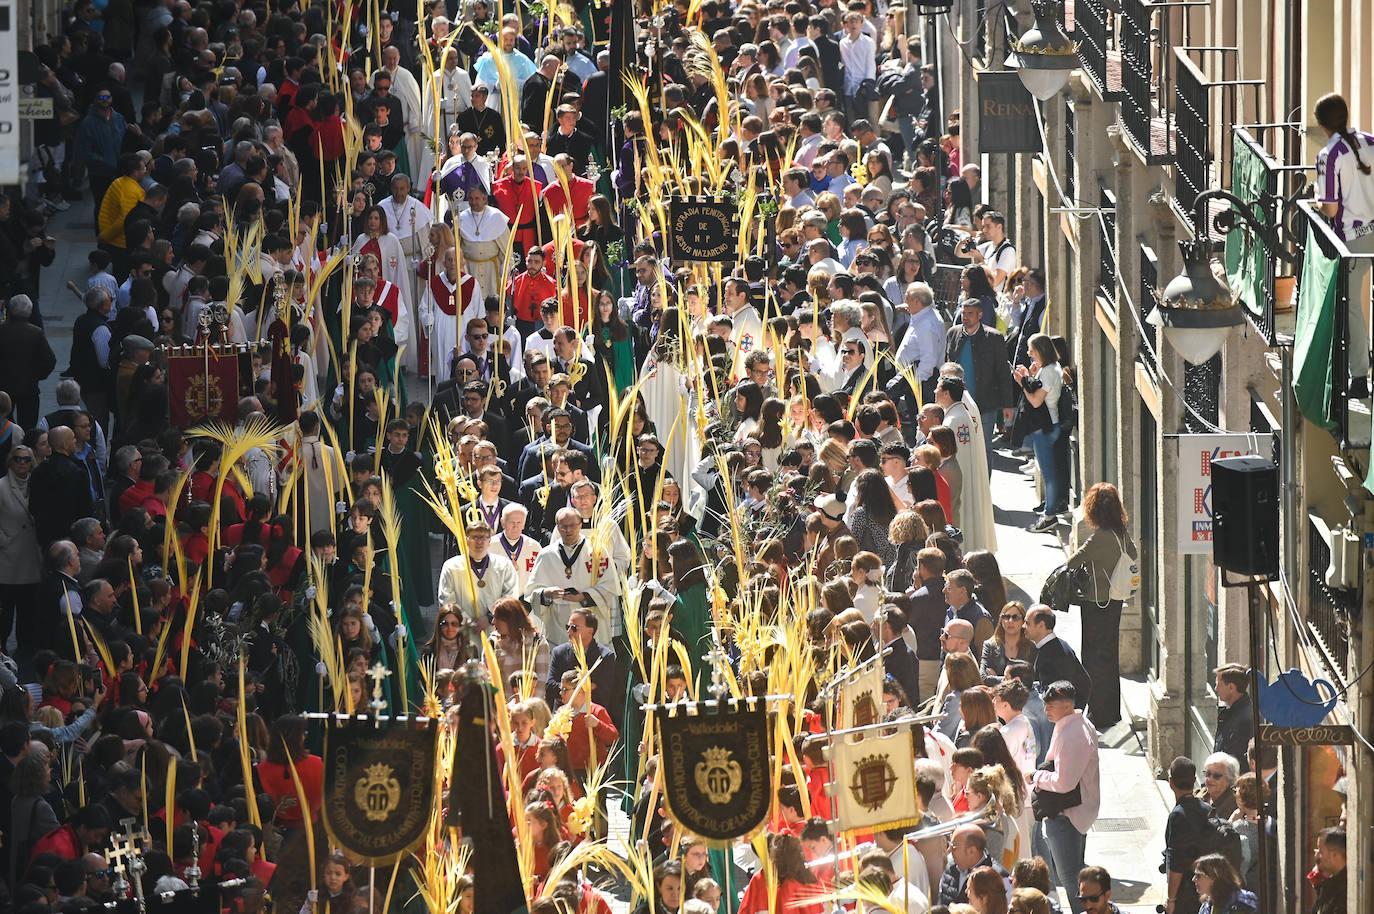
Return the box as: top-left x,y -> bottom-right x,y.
1212,456 -> 1279,576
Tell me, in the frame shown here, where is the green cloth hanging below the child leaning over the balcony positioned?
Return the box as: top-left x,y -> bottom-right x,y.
1293,228 -> 1341,430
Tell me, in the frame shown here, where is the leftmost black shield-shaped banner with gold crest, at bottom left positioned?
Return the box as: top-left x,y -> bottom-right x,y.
323,720 -> 438,866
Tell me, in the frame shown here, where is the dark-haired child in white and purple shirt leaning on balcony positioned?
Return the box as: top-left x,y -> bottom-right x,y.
1315,92 -> 1374,400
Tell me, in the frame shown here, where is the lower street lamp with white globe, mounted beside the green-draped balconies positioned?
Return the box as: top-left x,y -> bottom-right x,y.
1146,241 -> 1245,366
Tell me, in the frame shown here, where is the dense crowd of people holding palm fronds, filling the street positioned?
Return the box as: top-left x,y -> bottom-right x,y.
0,0 -> 1344,914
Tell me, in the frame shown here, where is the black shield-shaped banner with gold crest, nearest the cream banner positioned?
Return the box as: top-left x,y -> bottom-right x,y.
654,698 -> 772,841
